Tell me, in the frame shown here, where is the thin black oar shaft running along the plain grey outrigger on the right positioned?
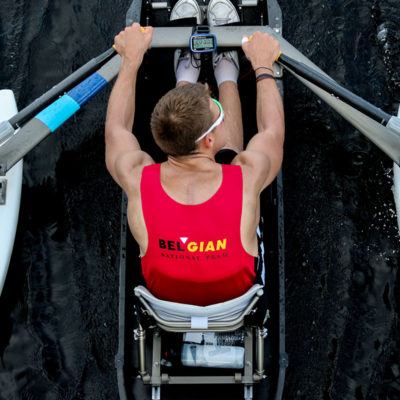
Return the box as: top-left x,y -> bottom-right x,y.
277,54 -> 392,126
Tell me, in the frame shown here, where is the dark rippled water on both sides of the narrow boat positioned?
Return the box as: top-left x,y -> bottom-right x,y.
0,0 -> 400,400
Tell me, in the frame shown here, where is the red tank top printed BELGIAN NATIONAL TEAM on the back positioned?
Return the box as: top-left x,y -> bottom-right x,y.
140,164 -> 255,306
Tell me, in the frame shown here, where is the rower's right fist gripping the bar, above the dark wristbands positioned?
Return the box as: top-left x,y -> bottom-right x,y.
242,31 -> 280,70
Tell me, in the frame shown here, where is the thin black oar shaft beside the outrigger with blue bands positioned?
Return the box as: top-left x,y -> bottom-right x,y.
8,48 -> 116,129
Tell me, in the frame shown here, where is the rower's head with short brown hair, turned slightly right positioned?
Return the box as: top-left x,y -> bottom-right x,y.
150,83 -> 221,157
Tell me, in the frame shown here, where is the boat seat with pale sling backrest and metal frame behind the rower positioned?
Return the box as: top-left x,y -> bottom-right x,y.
134,284 -> 268,400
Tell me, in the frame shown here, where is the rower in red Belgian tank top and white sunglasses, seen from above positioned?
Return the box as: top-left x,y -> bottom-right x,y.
106,0 -> 284,305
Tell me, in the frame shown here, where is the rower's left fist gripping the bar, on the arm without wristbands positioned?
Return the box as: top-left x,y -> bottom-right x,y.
114,22 -> 153,67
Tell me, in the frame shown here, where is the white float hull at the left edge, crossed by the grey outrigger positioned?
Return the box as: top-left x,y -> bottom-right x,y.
0,89 -> 23,294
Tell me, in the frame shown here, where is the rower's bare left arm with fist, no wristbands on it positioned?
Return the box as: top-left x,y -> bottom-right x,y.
105,24 -> 152,187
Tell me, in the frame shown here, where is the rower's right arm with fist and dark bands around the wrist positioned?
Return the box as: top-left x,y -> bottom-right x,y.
238,32 -> 285,191
